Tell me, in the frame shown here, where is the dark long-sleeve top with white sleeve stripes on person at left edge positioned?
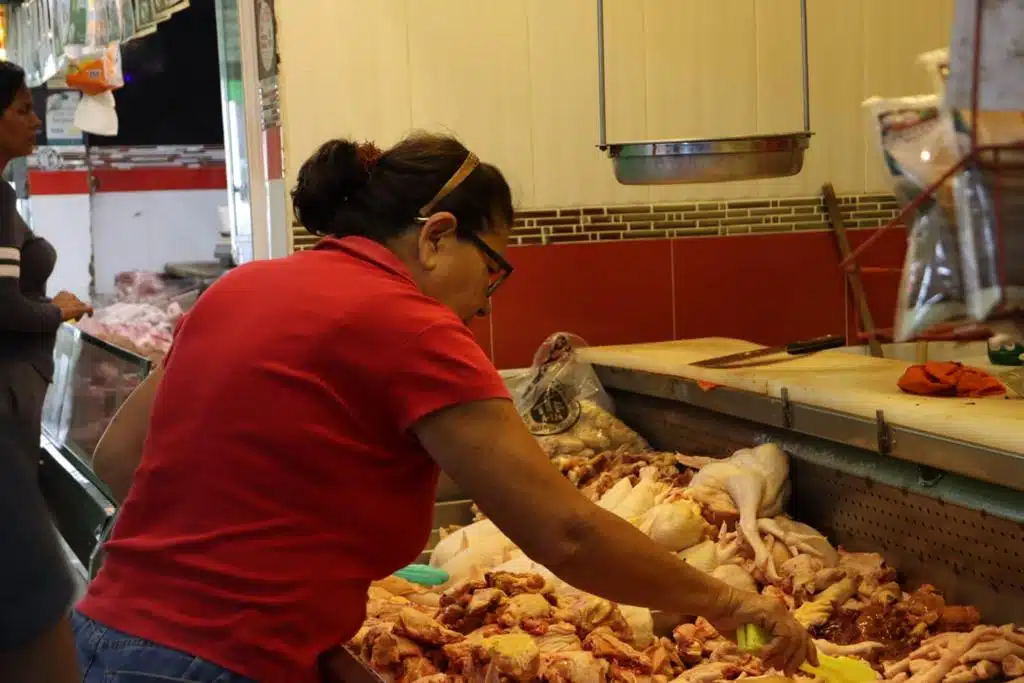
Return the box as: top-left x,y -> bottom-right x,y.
0,182 -> 61,379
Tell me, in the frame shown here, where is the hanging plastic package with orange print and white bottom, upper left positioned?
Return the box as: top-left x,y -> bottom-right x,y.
65,0 -> 130,135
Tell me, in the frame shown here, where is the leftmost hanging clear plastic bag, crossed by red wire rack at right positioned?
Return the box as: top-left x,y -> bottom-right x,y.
863,95 -> 967,342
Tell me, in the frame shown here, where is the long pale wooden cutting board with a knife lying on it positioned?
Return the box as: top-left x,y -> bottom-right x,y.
581,337 -> 1024,455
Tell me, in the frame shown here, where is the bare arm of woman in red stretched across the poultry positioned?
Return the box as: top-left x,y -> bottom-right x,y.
414,399 -> 814,671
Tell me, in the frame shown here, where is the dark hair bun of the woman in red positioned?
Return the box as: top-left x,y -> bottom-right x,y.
292,139 -> 370,234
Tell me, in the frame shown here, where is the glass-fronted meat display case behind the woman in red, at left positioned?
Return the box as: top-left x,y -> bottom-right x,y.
39,325 -> 151,578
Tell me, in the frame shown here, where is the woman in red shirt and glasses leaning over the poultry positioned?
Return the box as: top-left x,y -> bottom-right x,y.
74,135 -> 814,683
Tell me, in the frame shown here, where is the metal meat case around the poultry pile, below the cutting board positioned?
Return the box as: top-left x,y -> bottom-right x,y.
362,360 -> 1024,683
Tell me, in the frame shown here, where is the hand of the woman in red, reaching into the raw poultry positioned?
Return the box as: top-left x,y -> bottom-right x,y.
707,590 -> 818,676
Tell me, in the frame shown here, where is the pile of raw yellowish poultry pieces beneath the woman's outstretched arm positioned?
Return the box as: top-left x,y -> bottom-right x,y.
349,405 -> 1024,683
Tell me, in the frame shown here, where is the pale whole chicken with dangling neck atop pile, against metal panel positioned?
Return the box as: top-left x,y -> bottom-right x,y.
690,443 -> 790,570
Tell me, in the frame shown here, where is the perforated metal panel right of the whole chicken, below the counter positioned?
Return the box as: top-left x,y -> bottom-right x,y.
792,462 -> 1024,623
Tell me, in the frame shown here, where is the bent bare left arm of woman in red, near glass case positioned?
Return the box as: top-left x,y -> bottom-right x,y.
92,364 -> 164,503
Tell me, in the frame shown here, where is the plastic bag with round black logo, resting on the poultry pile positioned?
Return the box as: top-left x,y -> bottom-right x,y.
512,333 -> 650,458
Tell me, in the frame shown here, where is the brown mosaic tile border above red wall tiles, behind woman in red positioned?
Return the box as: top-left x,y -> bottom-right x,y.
294,194 -> 899,249
